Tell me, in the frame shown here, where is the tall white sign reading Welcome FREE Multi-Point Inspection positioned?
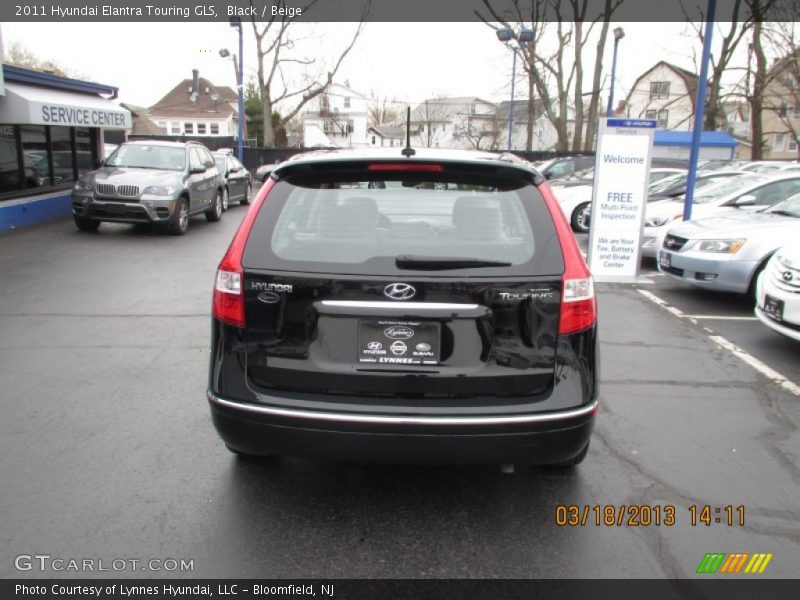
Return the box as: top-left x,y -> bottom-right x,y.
588,119 -> 656,282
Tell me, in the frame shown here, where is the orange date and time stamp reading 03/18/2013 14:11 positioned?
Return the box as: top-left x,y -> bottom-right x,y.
555,504 -> 745,527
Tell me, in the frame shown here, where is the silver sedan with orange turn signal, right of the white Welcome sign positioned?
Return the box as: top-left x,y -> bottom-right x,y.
658,193 -> 800,294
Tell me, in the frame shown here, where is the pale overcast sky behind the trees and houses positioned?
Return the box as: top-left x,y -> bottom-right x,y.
2,22 -> 744,112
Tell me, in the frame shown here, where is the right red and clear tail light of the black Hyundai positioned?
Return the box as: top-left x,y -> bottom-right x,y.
539,183 -> 597,335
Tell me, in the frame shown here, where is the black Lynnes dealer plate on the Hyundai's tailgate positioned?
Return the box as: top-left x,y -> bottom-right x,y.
358,320 -> 440,365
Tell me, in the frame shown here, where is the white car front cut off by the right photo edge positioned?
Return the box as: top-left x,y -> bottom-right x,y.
755,240 -> 800,341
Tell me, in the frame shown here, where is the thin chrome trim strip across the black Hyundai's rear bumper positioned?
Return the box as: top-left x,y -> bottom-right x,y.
206,392 -> 597,425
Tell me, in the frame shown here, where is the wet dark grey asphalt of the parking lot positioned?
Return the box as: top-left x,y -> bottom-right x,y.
0,213 -> 800,578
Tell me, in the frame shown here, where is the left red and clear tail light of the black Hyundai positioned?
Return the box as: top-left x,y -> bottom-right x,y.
211,178 -> 275,327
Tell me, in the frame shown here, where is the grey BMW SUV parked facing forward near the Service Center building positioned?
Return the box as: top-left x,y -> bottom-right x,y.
72,140 -> 225,235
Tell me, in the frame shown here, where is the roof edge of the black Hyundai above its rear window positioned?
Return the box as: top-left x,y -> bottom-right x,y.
273,146 -> 541,178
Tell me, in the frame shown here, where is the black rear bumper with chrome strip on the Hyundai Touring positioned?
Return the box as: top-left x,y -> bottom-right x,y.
208,392 -> 597,464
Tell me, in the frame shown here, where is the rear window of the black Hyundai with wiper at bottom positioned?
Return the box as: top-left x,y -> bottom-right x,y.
244,172 -> 563,276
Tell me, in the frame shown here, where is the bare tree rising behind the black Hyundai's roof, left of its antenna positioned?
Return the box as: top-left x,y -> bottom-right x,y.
250,0 -> 370,147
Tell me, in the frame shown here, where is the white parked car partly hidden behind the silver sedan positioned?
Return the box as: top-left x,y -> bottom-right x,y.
642,172 -> 800,258
